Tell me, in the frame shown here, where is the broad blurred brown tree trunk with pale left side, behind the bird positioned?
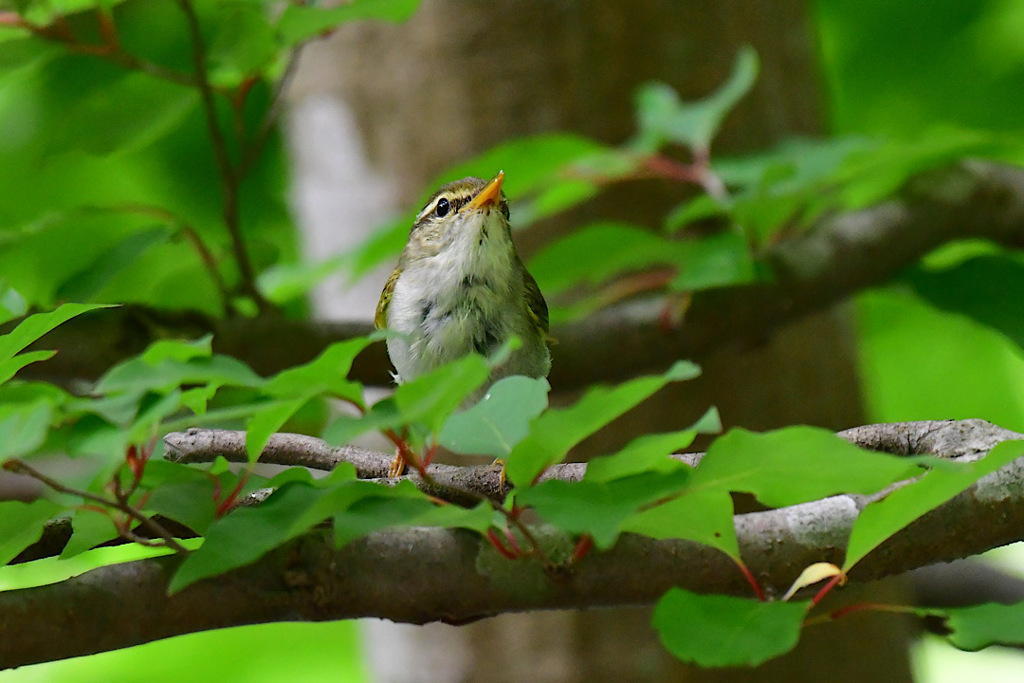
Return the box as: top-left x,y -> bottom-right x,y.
291,0 -> 909,683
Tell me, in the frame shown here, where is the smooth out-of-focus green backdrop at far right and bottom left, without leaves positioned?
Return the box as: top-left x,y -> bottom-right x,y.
0,0 -> 1024,683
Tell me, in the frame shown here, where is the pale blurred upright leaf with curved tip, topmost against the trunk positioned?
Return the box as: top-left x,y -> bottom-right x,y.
634,46 -> 759,154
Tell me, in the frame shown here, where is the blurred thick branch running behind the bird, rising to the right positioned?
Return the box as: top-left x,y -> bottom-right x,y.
14,156 -> 1024,389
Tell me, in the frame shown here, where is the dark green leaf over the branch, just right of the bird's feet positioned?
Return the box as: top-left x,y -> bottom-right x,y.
516,471 -> 690,550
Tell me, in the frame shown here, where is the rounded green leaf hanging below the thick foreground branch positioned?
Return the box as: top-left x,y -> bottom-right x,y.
653,588 -> 808,668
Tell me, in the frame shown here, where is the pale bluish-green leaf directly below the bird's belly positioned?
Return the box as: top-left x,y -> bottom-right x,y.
438,376 -> 551,458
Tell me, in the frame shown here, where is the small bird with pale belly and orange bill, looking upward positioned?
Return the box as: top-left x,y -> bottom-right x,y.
374,172 -> 551,400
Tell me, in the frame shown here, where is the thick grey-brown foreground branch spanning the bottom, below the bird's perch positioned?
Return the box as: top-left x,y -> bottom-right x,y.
0,421 -> 1024,668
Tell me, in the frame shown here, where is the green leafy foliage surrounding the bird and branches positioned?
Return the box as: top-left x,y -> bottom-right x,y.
0,0 -> 1024,667
